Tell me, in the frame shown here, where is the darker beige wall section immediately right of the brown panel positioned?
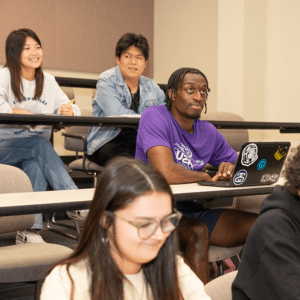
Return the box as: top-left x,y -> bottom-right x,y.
154,0 -> 218,110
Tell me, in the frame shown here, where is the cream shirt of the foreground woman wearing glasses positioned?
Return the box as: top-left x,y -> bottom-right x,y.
40,257 -> 210,300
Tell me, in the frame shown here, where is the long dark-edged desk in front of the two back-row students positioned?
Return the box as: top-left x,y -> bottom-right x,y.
0,113 -> 300,133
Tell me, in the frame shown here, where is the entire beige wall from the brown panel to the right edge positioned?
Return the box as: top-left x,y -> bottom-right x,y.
154,0 -> 300,145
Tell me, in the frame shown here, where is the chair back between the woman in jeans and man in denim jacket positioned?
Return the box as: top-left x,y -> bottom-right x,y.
64,106 -> 93,152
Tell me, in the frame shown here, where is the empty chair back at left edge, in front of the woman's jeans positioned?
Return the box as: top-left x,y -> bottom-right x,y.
0,164 -> 35,233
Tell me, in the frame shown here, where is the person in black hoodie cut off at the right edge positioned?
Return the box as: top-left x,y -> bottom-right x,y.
232,146 -> 300,300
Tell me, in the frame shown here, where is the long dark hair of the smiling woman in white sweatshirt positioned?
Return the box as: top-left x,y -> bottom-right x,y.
4,28 -> 44,102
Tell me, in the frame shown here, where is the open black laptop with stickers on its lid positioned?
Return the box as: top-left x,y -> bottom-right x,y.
198,142 -> 291,187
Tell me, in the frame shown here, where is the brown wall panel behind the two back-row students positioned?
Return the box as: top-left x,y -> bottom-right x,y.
0,0 -> 154,77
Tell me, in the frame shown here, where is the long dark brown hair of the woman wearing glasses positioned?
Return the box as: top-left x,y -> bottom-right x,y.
57,157 -> 183,300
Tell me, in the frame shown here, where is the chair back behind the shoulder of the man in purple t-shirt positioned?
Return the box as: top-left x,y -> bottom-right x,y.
201,111 -> 249,152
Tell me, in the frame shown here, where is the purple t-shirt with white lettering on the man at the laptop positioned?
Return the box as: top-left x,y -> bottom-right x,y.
135,105 -> 238,171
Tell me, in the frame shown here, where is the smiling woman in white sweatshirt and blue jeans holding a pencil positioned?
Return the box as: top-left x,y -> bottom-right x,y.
0,28 -> 80,243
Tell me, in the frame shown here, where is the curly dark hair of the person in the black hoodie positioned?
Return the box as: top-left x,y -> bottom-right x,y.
284,146 -> 300,197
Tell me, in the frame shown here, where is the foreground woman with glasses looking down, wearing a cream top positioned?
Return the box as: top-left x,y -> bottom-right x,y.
41,157 -> 209,300
